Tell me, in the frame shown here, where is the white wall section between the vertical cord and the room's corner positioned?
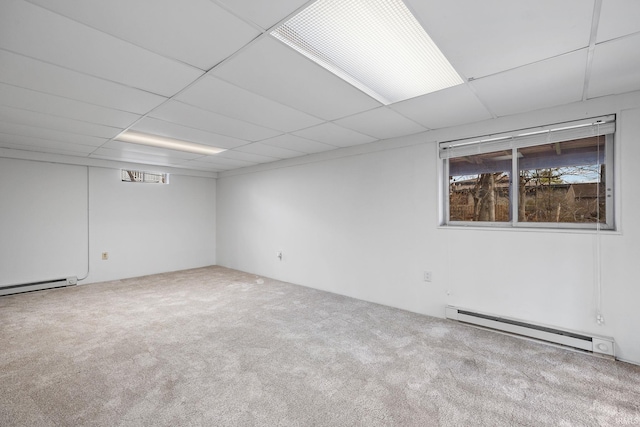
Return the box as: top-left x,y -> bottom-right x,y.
86,168 -> 216,283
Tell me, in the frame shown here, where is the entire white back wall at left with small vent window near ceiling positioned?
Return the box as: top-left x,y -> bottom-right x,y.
0,158 -> 216,285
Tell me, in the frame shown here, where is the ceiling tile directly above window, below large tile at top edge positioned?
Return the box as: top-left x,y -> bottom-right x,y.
470,49 -> 587,116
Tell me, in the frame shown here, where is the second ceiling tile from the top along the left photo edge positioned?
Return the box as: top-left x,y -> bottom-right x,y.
0,50 -> 166,114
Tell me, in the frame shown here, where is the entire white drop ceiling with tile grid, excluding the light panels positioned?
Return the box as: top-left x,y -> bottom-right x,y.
0,0 -> 640,171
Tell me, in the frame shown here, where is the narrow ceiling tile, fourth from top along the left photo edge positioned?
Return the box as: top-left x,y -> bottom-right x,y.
0,106 -> 121,138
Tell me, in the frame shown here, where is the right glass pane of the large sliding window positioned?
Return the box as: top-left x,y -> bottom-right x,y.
518,136 -> 606,223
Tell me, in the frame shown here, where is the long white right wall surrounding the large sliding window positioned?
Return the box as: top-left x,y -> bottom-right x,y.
217,93 -> 640,363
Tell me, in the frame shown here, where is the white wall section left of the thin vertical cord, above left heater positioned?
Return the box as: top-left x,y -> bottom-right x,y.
0,158 -> 87,286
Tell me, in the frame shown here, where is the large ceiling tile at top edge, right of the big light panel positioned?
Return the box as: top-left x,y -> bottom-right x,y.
407,0 -> 594,78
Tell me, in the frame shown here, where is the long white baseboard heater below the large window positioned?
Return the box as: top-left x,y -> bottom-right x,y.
446,306 -> 614,356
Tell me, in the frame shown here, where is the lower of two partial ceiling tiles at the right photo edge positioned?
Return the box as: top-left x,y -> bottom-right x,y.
588,34 -> 640,98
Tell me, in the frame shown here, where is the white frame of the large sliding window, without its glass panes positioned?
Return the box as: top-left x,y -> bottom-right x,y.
438,115 -> 616,230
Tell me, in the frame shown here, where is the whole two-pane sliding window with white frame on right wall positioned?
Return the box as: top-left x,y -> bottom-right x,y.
439,116 -> 615,229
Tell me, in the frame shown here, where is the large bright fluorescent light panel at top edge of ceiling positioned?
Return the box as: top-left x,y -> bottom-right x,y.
271,0 -> 463,105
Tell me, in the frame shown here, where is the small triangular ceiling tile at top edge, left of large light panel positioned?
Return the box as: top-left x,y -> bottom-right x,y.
219,0 -> 309,29
